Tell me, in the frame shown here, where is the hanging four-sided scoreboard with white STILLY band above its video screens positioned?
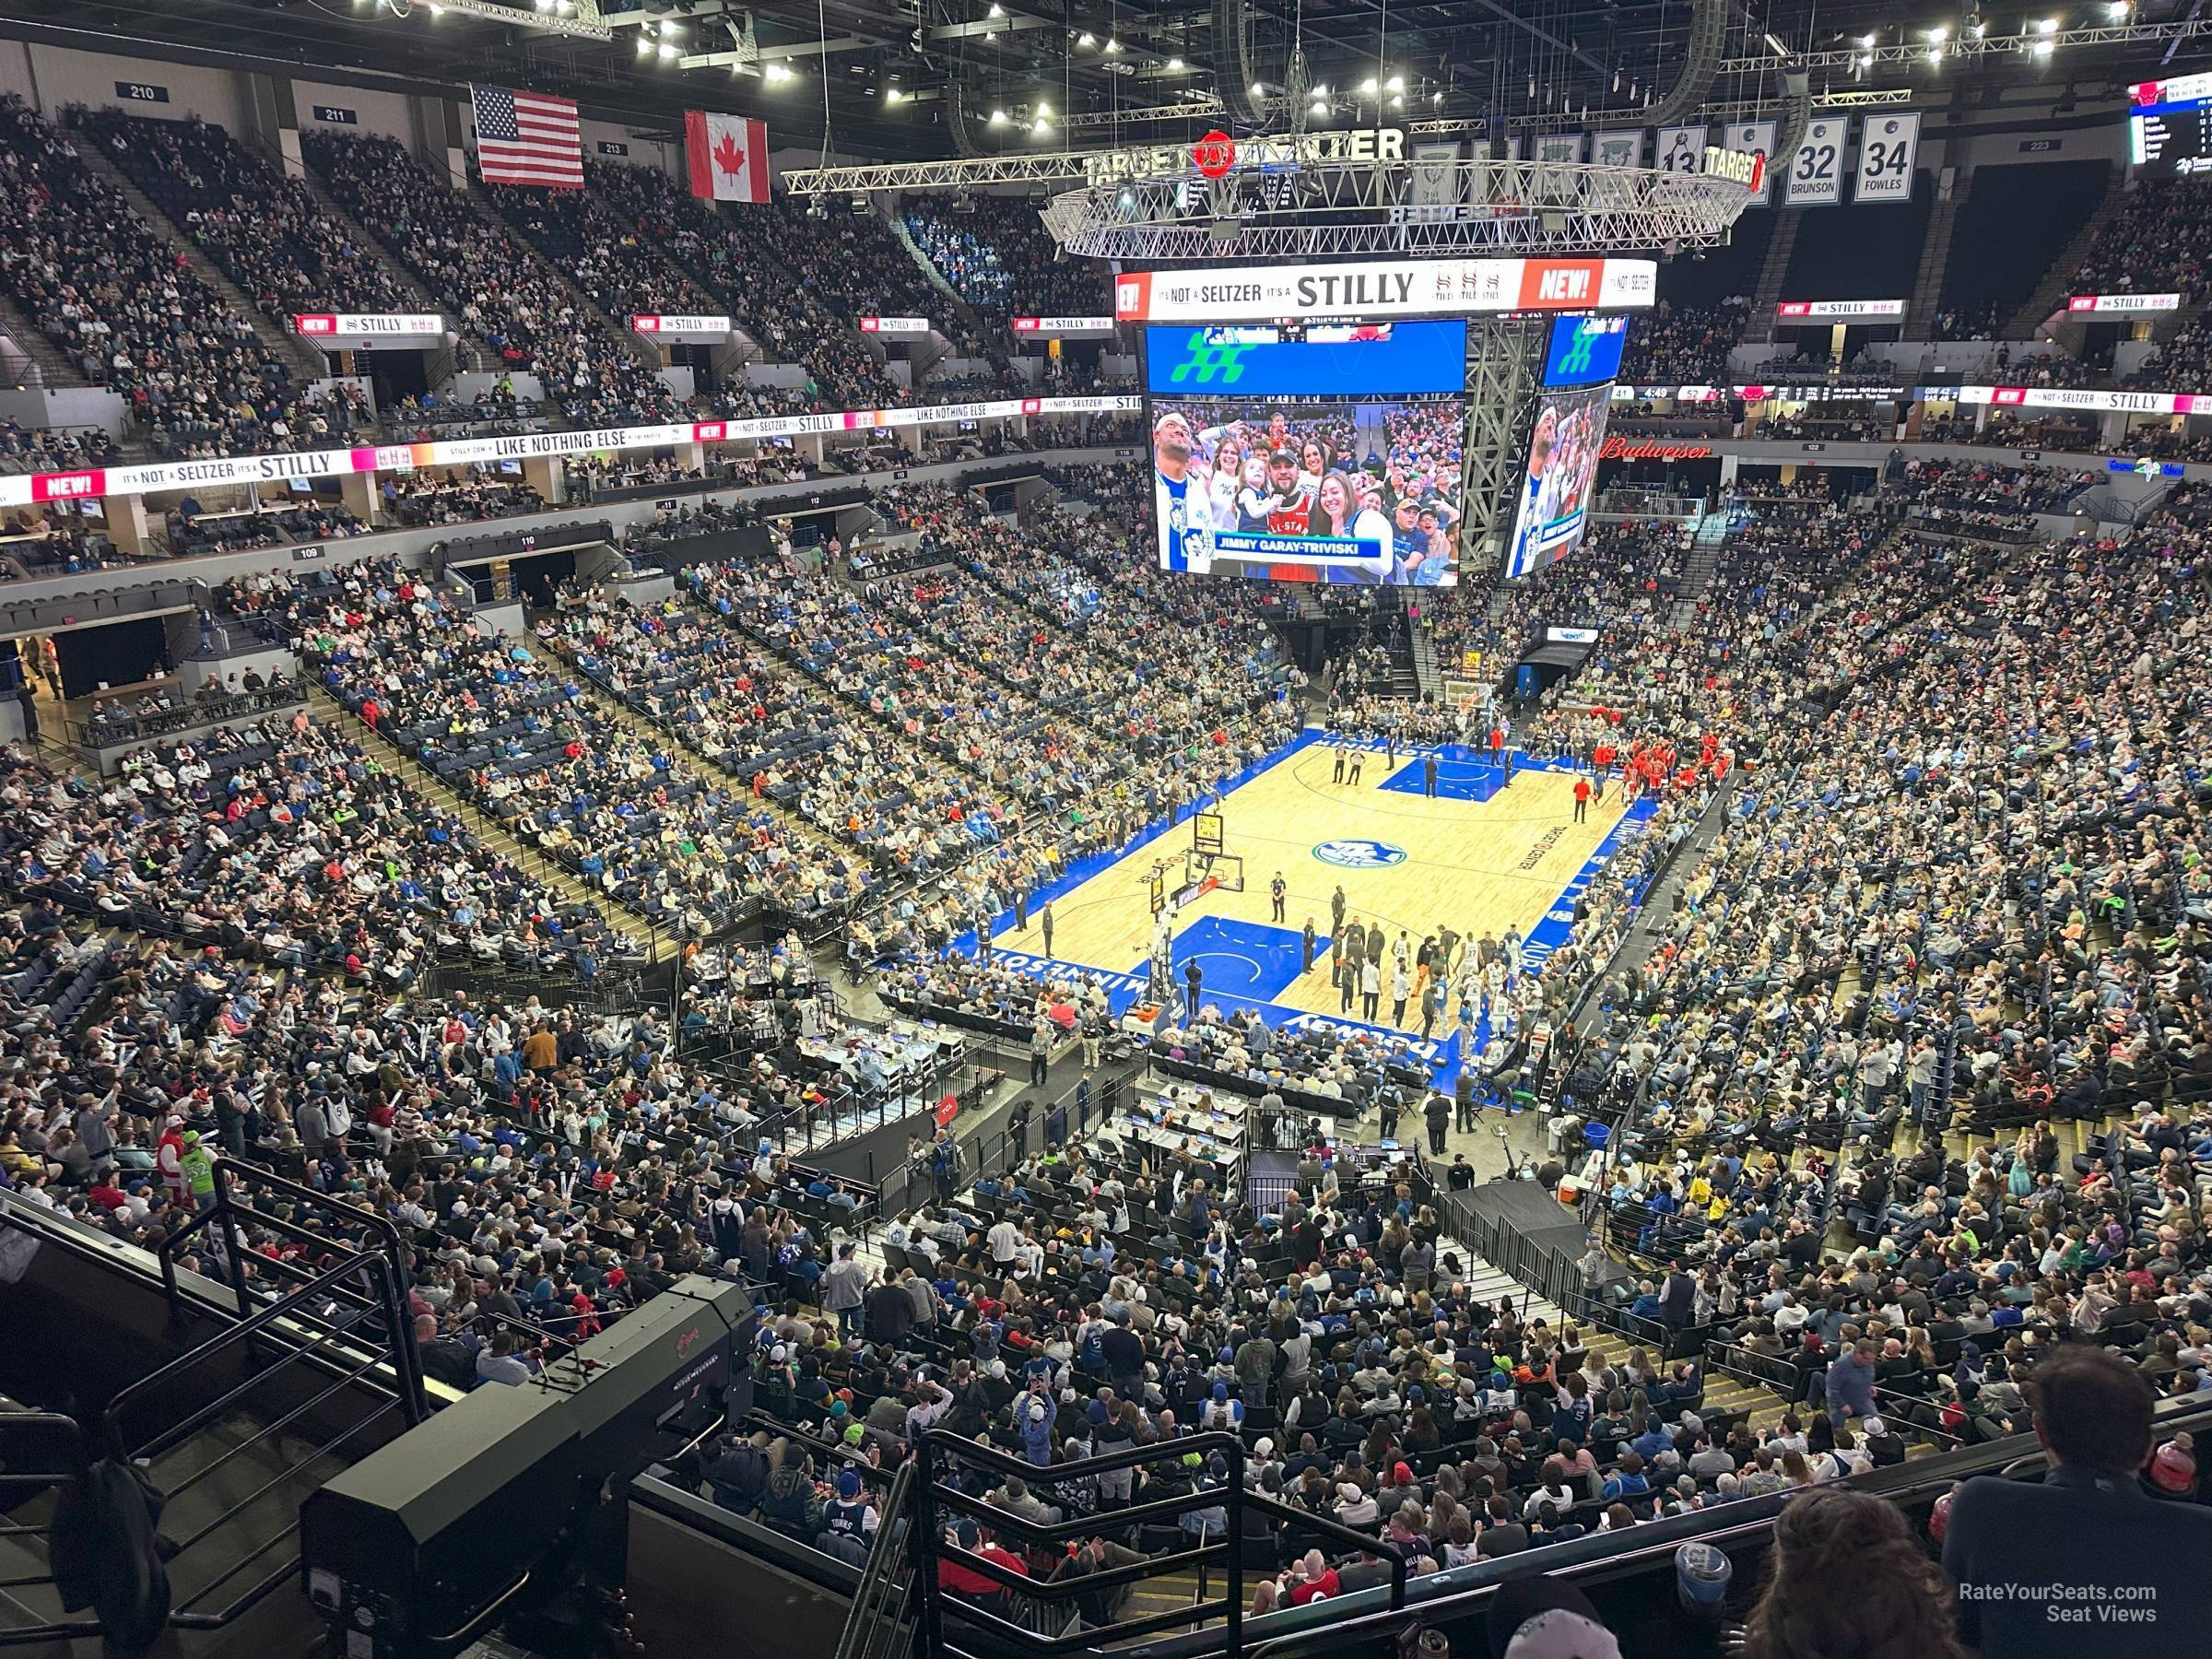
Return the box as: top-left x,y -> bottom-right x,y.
1115,256 -> 1657,588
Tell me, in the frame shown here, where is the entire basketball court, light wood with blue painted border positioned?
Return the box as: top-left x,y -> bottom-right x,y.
994,730 -> 1650,1079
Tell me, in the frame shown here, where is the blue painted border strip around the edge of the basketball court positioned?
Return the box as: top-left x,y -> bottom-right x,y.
951,725 -> 1659,1088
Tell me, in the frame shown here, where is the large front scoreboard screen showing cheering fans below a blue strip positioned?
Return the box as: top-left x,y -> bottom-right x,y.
1144,323 -> 1466,588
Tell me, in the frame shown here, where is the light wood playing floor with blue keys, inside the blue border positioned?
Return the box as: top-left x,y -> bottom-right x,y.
1018,746 -> 1626,1035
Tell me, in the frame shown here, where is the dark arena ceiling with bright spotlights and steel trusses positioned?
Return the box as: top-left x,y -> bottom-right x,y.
0,0 -> 2212,159
